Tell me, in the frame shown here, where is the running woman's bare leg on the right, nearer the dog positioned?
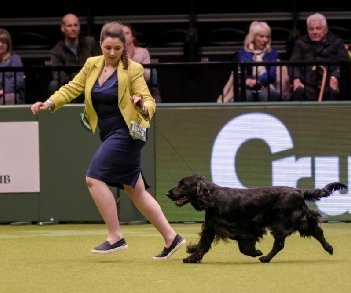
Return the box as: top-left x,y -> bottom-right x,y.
124,175 -> 177,247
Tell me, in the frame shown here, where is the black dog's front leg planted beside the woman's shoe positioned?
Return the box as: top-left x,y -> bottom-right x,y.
183,228 -> 215,263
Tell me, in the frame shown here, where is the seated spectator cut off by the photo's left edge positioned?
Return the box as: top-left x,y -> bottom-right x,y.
0,28 -> 25,105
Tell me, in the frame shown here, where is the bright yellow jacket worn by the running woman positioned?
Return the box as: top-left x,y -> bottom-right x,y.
49,55 -> 156,132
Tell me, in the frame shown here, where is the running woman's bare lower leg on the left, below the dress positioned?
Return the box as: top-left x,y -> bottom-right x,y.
86,177 -> 123,244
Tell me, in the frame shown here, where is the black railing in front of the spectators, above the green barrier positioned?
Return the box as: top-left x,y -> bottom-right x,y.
0,61 -> 351,105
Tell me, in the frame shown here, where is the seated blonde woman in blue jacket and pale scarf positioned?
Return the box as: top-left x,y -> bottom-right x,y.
238,21 -> 280,102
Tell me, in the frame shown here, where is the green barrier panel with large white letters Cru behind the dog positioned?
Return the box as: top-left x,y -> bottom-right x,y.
155,102 -> 351,221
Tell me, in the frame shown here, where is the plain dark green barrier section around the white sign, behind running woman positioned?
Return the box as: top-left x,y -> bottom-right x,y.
0,105 -> 155,223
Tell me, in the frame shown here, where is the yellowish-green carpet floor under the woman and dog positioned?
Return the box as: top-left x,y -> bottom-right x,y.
0,223 -> 351,293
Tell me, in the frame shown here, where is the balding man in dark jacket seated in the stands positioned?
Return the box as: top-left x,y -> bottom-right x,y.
49,13 -> 101,103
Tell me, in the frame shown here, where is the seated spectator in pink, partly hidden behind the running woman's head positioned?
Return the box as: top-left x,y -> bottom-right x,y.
123,23 -> 161,102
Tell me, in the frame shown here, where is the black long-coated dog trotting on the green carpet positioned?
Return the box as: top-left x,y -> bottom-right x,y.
167,174 -> 347,263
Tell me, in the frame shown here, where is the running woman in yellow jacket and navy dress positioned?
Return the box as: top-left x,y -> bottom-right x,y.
31,22 -> 185,259
